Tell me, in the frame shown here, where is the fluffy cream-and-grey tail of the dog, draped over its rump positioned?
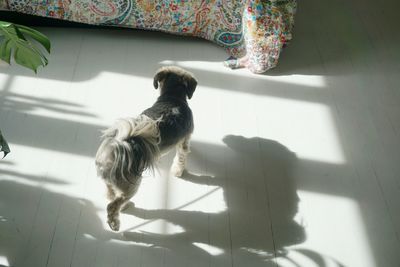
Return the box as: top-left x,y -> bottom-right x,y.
96,115 -> 160,183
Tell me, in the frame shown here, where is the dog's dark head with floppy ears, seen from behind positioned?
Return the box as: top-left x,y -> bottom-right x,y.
153,66 -> 197,99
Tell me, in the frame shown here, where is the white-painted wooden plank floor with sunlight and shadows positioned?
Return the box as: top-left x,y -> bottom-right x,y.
0,0 -> 400,267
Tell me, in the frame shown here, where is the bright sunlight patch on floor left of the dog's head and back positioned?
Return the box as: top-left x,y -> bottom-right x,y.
0,71 -> 159,125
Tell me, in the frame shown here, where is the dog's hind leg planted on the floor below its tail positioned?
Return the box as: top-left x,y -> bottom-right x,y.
107,180 -> 141,231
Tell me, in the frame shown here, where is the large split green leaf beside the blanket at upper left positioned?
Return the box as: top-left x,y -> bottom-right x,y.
0,21 -> 51,73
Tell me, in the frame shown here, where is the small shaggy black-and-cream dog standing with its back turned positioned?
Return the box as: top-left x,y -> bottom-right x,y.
96,66 -> 197,231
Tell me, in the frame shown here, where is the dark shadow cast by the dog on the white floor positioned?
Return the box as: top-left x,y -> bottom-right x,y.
123,135 -> 305,265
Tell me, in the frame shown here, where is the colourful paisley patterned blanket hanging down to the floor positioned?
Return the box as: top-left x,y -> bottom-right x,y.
0,0 -> 296,73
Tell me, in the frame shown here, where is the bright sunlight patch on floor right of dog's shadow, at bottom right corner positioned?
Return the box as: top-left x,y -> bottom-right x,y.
295,190 -> 374,266
